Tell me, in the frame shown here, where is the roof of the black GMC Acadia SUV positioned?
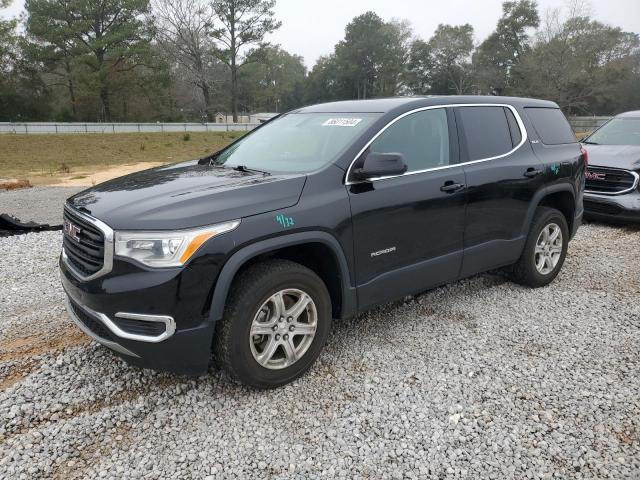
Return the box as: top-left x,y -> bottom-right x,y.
295,95 -> 558,113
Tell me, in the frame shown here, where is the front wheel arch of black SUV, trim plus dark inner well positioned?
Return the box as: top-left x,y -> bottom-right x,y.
209,231 -> 357,322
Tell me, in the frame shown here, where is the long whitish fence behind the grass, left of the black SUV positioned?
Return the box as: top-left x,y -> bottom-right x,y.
0,122 -> 259,134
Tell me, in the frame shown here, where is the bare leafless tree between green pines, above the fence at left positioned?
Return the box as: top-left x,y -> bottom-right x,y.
154,0 -> 217,121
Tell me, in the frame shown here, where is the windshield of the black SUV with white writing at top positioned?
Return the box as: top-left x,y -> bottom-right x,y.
213,113 -> 381,173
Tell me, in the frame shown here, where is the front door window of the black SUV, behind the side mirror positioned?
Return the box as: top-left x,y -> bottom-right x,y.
369,108 -> 449,172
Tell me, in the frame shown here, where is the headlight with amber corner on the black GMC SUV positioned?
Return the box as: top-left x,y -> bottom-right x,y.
115,220 -> 240,267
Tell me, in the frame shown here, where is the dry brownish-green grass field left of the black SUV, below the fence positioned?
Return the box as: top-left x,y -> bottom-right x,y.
0,132 -> 243,178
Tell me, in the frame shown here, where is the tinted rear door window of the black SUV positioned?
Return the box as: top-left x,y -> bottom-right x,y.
456,106 -> 513,161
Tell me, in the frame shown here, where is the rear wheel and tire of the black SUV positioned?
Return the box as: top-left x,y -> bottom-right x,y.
511,207 -> 569,288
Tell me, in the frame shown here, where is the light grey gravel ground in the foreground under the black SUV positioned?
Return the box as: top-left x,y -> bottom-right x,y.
0,225 -> 640,479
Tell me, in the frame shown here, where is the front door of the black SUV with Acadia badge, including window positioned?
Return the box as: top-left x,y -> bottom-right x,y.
347,108 -> 465,309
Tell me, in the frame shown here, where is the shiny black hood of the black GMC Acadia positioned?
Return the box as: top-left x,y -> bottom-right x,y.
68,160 -> 306,230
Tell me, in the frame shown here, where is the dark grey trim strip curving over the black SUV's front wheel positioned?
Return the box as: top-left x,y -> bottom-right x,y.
209,231 -> 357,322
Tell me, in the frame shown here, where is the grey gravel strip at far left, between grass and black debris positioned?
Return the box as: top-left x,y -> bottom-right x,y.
0,187 -> 87,225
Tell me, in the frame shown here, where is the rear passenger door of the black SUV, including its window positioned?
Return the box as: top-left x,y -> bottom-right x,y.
455,105 -> 544,276
